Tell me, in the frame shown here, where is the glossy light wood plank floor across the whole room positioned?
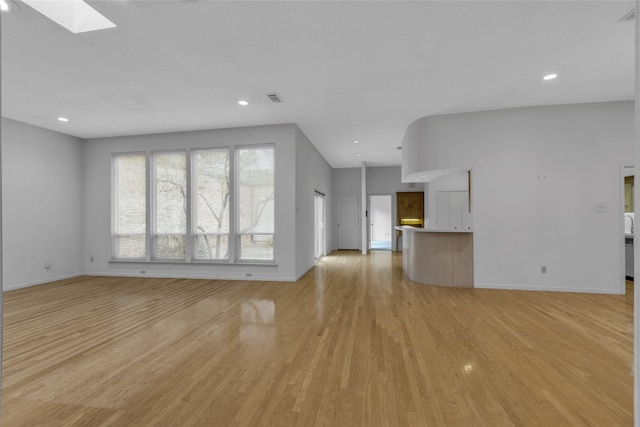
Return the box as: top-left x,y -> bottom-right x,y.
2,251 -> 633,427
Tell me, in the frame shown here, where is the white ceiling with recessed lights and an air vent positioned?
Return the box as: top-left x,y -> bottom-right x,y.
2,0 -> 634,168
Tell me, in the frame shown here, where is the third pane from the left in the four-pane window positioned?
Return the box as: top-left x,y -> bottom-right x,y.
193,150 -> 231,260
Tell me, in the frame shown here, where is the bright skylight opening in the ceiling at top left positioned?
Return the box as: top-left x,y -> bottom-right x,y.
20,0 -> 116,34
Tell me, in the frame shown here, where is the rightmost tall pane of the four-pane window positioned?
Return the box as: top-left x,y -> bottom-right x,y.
236,147 -> 275,260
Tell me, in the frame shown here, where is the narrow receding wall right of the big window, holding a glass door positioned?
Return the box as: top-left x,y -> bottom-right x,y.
295,126 -> 336,277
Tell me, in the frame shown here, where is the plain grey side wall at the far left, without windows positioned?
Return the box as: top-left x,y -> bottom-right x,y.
2,118 -> 83,290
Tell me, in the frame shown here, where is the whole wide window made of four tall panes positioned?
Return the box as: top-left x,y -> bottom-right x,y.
113,146 -> 275,262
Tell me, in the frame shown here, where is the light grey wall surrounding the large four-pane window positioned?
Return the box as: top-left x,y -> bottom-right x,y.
83,124 -> 300,280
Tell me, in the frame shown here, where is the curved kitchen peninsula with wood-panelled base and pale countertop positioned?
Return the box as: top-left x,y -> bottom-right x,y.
396,227 -> 473,288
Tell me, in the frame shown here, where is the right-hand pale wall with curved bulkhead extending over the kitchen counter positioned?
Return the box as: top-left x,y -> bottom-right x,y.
402,102 -> 634,293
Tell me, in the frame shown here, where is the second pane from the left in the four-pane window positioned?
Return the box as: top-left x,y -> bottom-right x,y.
153,153 -> 187,259
